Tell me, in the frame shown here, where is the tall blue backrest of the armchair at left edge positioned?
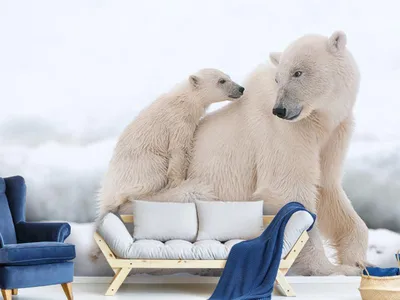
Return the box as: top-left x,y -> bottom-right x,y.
0,176 -> 26,246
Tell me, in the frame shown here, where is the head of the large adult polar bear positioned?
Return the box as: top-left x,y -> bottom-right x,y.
270,31 -> 359,121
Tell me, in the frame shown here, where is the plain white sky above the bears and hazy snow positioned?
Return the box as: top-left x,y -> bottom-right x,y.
0,0 -> 400,139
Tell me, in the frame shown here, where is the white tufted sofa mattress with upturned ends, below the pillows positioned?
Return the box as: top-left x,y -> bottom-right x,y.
98,211 -> 314,260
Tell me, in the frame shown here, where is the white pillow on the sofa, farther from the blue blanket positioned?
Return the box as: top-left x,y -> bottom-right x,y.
133,200 -> 197,242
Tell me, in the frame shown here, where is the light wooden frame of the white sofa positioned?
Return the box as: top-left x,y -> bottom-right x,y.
94,215 -> 309,297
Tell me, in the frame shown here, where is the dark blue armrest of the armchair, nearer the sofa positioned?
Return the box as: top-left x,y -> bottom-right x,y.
15,222 -> 71,243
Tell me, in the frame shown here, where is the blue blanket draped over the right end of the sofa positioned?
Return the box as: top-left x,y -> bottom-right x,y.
210,202 -> 315,300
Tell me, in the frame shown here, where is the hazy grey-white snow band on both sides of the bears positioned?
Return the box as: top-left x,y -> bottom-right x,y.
0,138 -> 400,231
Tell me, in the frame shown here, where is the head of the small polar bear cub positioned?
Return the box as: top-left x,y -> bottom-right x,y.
189,69 -> 244,105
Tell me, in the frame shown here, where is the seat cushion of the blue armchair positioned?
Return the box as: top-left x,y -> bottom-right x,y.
0,242 -> 75,266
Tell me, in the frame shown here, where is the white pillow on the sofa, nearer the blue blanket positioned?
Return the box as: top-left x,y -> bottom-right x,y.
196,201 -> 264,242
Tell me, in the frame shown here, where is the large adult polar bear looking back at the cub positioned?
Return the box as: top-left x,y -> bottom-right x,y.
142,32 -> 368,275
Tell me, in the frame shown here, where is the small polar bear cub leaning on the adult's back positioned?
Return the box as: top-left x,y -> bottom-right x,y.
98,69 -> 244,221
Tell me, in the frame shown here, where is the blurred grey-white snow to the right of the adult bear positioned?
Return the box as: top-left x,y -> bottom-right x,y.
344,140 -> 400,231
